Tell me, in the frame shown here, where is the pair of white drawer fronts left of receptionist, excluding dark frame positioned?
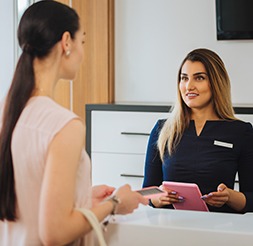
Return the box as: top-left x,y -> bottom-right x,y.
91,110 -> 169,189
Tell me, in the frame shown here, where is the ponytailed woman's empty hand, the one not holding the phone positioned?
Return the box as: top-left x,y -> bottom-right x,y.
92,185 -> 115,206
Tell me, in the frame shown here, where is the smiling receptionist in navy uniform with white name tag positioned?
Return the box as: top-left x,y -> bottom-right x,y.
143,49 -> 253,213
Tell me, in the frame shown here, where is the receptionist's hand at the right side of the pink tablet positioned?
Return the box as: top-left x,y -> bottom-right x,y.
202,184 -> 231,207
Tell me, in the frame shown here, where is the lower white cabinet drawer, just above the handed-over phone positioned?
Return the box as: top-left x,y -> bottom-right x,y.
92,153 -> 145,190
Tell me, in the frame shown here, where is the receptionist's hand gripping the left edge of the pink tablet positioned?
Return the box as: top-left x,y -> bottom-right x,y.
151,185 -> 184,208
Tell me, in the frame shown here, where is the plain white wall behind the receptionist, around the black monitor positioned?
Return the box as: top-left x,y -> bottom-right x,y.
115,0 -> 253,104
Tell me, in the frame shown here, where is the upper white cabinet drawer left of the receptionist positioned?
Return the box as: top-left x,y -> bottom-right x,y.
91,111 -> 169,154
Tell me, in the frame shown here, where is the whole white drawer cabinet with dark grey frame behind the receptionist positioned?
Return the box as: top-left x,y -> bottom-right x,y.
86,104 -> 253,190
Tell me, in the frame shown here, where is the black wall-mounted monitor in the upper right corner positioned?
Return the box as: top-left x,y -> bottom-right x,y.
216,0 -> 253,40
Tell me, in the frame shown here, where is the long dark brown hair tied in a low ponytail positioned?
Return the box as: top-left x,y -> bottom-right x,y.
0,0 -> 79,221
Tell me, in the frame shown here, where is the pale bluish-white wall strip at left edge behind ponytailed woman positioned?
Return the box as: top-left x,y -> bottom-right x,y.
0,0 -> 16,100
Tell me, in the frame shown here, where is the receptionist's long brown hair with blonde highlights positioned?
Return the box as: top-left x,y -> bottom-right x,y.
157,48 -> 236,159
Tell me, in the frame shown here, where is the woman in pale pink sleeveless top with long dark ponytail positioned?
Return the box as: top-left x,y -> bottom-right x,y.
0,1 -> 147,246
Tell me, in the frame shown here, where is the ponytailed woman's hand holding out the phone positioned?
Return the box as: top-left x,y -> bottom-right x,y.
115,184 -> 148,214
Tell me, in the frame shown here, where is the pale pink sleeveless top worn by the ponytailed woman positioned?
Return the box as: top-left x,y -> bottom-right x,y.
0,96 -> 91,246
